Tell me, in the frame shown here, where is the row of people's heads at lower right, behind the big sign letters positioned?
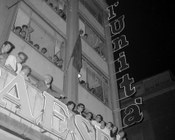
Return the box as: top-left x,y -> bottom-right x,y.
66,101 -> 125,140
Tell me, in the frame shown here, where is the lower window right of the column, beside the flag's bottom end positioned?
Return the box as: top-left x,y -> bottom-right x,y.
79,59 -> 109,104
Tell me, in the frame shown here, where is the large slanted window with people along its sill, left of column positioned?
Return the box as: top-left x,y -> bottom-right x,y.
13,3 -> 65,68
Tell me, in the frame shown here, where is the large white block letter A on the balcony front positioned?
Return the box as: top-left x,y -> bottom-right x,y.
0,75 -> 33,120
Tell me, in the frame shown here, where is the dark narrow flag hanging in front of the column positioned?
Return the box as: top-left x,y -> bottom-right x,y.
71,35 -> 82,72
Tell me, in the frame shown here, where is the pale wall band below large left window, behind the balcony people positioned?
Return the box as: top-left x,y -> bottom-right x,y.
8,31 -> 64,91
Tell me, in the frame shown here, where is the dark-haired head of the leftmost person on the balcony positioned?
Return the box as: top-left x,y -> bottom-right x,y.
1,41 -> 15,54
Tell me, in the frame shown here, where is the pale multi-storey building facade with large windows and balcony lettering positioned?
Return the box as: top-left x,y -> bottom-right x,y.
0,0 -> 122,140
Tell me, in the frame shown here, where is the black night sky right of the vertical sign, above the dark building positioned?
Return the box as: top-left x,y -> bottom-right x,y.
107,0 -> 175,82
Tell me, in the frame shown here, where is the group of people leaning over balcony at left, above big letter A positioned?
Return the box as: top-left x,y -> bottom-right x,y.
0,41 -> 66,102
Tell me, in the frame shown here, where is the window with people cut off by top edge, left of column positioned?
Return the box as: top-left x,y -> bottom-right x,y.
45,0 -> 66,20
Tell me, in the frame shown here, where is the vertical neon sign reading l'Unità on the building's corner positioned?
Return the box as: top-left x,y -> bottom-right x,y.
107,2 -> 143,127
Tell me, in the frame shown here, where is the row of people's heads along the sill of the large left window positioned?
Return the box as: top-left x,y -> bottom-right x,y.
13,25 -> 63,68
